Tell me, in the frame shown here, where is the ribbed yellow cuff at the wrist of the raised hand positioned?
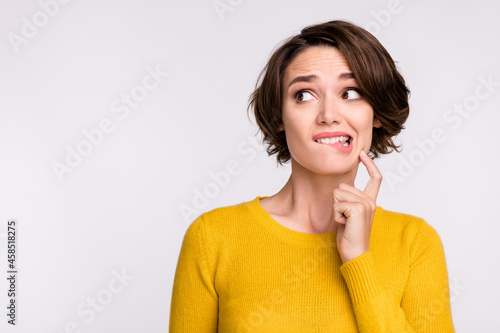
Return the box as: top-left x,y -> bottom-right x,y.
340,251 -> 383,305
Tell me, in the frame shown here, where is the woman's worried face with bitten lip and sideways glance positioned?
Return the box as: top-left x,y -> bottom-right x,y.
279,46 -> 381,174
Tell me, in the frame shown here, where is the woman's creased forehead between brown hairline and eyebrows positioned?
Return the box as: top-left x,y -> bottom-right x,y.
284,45 -> 351,82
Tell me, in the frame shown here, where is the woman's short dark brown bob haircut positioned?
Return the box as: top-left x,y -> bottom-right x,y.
247,20 -> 410,165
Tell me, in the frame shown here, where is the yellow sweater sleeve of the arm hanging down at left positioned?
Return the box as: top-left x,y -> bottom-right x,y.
169,216 -> 219,333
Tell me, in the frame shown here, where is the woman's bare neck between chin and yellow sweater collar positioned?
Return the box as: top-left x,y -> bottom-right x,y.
275,158 -> 358,234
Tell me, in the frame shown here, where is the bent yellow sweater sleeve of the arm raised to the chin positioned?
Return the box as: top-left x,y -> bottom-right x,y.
340,220 -> 455,333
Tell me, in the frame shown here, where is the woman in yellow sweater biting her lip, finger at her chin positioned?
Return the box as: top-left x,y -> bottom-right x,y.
170,21 -> 454,333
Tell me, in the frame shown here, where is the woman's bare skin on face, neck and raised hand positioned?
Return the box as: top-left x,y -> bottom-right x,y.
260,46 -> 382,263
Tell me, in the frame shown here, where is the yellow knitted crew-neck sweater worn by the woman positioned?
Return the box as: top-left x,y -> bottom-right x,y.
170,196 -> 454,333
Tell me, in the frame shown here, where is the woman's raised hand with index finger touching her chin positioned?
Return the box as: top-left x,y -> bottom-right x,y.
333,151 -> 382,263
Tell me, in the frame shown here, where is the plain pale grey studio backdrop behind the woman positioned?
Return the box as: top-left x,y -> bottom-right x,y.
0,0 -> 500,333
